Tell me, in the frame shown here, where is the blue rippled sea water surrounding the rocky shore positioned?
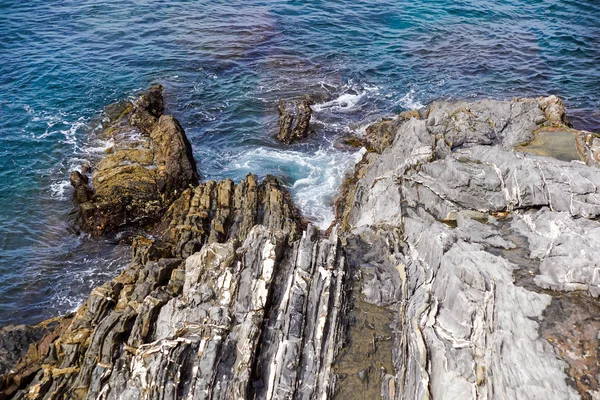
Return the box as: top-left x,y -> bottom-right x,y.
0,0 -> 600,325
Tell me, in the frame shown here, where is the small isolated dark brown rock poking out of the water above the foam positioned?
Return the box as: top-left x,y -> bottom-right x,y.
277,99 -> 312,144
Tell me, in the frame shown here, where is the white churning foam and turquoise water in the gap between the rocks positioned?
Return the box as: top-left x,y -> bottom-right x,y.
226,82 -> 380,229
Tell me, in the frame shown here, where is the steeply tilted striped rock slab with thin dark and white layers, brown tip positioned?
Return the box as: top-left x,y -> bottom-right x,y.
0,175 -> 346,399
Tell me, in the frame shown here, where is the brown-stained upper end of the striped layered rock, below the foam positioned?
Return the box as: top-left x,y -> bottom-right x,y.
163,175 -> 304,258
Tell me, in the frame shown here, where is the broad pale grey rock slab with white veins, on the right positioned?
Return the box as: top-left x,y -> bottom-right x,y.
338,97 -> 600,399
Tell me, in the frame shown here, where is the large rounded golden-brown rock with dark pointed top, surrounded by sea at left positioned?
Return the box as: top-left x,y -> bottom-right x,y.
71,86 -> 198,235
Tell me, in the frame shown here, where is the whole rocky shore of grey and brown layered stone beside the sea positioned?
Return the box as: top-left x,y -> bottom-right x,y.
0,88 -> 600,399
